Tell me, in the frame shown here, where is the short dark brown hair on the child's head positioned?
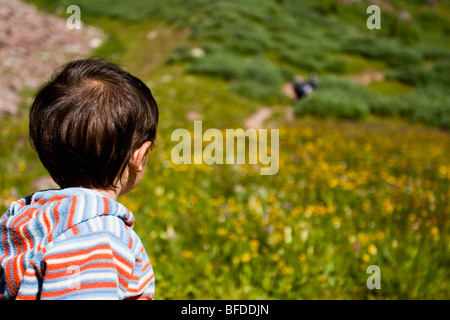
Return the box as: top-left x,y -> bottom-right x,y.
29,59 -> 159,189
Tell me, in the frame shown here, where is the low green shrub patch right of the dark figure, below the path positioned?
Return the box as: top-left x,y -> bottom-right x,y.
295,77 -> 450,128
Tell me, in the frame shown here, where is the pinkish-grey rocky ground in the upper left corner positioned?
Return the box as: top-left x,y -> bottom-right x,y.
0,0 -> 103,117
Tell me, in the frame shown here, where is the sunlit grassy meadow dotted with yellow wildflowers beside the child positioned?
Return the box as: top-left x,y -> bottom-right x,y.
0,1 -> 450,299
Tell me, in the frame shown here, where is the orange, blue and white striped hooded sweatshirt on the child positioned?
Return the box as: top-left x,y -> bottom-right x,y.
0,188 -> 155,300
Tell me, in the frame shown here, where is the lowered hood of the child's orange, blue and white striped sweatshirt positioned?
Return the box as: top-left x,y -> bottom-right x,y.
0,188 -> 134,298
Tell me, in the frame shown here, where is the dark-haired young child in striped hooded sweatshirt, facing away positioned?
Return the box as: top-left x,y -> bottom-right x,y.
0,59 -> 158,300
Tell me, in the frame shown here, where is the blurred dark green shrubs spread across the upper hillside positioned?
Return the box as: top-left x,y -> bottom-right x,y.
28,0 -> 450,127
